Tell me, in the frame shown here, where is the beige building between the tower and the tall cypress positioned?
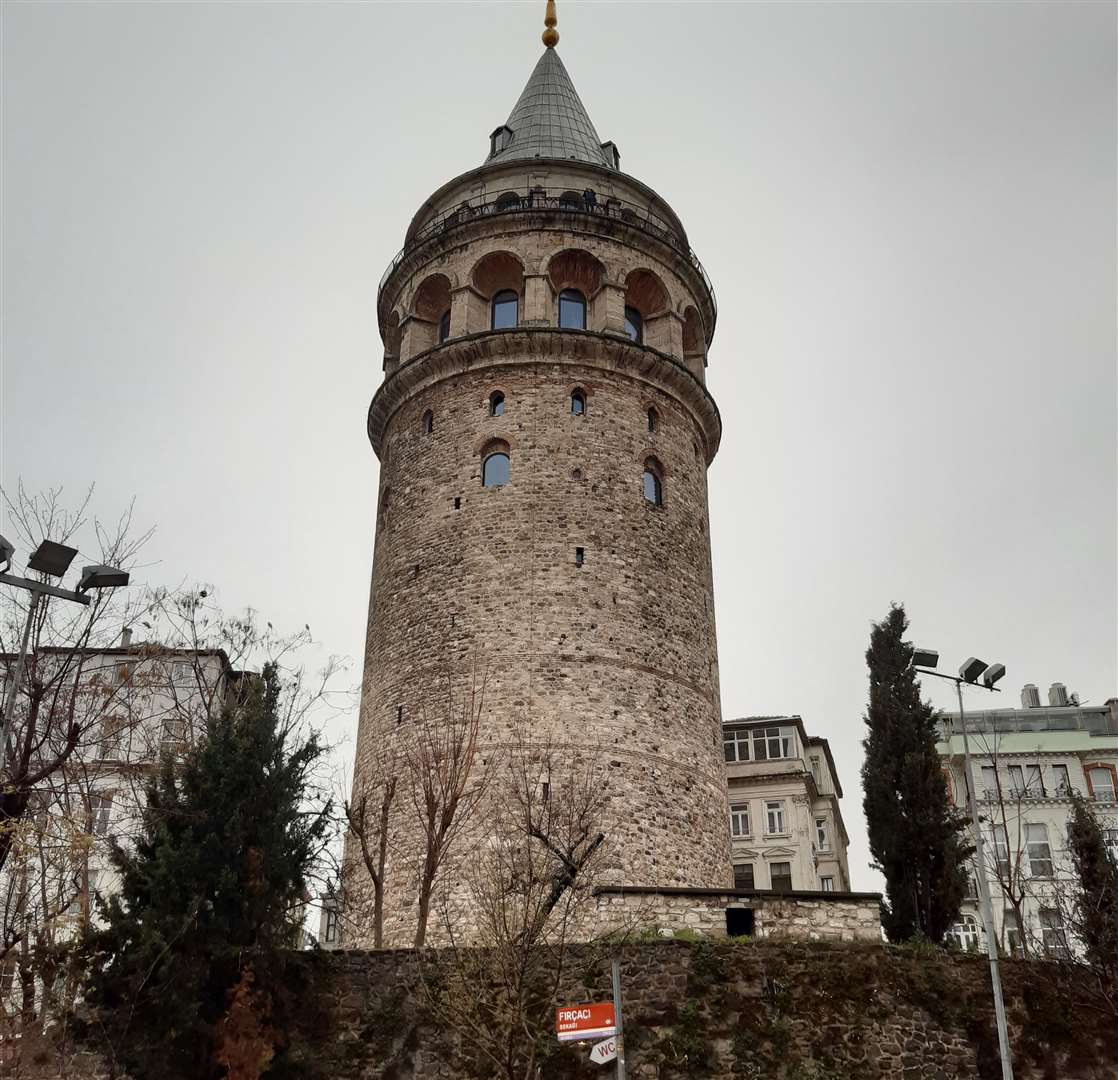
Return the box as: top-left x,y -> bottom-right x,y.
722,716 -> 850,892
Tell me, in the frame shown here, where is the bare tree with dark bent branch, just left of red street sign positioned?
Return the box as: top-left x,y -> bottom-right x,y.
421,739 -> 608,1080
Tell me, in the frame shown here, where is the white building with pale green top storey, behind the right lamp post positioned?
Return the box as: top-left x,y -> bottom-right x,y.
938,683 -> 1118,956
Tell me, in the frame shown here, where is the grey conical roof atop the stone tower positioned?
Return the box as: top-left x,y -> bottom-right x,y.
485,48 -> 616,169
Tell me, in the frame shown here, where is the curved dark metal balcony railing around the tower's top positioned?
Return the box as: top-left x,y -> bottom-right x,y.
377,188 -> 718,330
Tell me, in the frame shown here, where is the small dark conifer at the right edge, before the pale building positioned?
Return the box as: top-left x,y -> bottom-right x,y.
1068,793 -> 1118,986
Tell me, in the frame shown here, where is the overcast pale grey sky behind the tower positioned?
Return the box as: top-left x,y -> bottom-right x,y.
0,0 -> 1118,888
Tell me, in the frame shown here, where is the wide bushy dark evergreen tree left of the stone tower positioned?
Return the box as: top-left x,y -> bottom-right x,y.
87,665 -> 329,1080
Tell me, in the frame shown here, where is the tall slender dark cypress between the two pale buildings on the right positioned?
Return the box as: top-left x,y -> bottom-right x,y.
862,605 -> 972,942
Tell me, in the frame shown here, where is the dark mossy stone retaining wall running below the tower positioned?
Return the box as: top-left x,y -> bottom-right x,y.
26,941 -> 1118,1080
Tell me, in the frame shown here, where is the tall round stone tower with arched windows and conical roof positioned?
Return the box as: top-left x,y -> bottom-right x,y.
351,9 -> 730,945
